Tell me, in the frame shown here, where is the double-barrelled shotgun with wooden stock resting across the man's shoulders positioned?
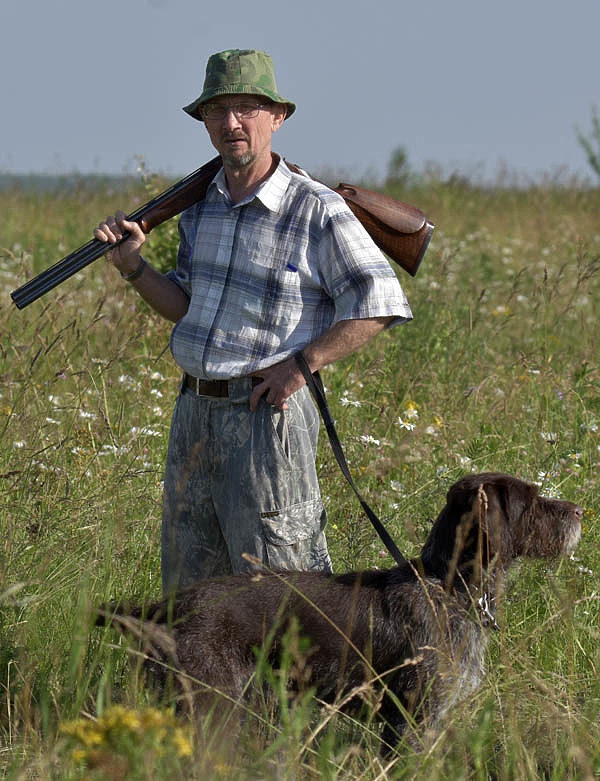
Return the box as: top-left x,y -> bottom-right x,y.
10,157 -> 434,309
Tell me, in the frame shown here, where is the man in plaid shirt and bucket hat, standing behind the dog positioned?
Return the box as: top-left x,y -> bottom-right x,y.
94,50 -> 412,592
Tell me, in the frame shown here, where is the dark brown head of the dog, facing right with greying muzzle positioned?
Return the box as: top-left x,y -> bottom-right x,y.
421,472 -> 583,581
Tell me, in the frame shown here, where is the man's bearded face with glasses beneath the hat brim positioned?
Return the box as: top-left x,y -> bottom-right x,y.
202,95 -> 285,168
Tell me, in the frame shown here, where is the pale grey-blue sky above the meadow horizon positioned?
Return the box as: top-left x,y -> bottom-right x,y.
0,0 -> 600,177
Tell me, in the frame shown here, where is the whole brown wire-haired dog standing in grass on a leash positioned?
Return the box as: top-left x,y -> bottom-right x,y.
98,473 -> 583,747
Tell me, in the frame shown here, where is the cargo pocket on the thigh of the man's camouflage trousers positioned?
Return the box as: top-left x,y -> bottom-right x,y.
260,499 -> 326,570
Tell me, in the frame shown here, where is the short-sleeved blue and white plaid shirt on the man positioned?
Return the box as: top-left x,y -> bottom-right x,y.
168,161 -> 412,380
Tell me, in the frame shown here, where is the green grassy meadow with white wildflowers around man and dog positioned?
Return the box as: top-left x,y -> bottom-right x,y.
0,168 -> 600,779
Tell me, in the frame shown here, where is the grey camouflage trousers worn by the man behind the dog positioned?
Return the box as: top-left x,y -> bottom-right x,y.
162,378 -> 332,593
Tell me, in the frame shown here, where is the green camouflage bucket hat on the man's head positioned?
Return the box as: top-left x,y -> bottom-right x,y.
183,49 -> 296,122
